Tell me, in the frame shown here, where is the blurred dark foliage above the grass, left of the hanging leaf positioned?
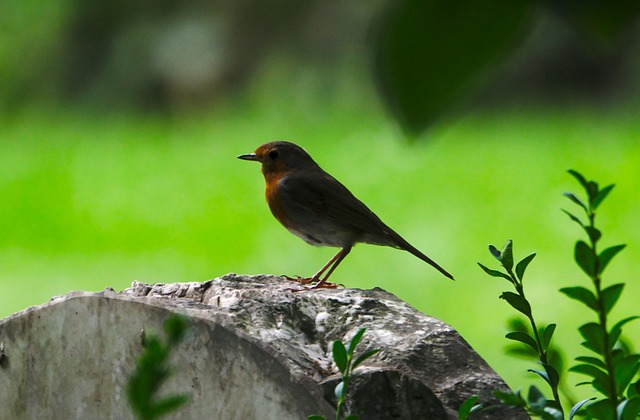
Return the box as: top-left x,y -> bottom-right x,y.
0,0 -> 380,108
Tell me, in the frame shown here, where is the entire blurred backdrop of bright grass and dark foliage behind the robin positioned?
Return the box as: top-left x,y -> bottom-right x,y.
0,0 -> 640,394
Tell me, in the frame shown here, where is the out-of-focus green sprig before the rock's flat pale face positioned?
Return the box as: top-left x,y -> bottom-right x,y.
127,314 -> 190,420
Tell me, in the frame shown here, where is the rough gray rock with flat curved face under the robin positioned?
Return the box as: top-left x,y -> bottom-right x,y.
0,274 -> 527,419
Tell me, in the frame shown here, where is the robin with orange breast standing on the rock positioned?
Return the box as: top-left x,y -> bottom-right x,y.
238,141 -> 453,289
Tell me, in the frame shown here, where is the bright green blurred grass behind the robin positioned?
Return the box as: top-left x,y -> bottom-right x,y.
0,69 -> 640,394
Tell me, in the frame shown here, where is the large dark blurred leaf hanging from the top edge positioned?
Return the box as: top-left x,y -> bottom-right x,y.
375,0 -> 532,134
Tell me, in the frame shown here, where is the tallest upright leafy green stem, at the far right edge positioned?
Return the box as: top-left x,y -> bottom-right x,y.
560,170 -> 640,419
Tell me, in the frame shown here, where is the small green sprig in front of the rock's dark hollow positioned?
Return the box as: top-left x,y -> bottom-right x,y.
307,328 -> 380,420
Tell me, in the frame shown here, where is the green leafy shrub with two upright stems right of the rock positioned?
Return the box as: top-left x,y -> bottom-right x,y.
459,170 -> 640,420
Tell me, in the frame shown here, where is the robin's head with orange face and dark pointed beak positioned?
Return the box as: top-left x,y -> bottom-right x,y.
238,141 -> 318,177
